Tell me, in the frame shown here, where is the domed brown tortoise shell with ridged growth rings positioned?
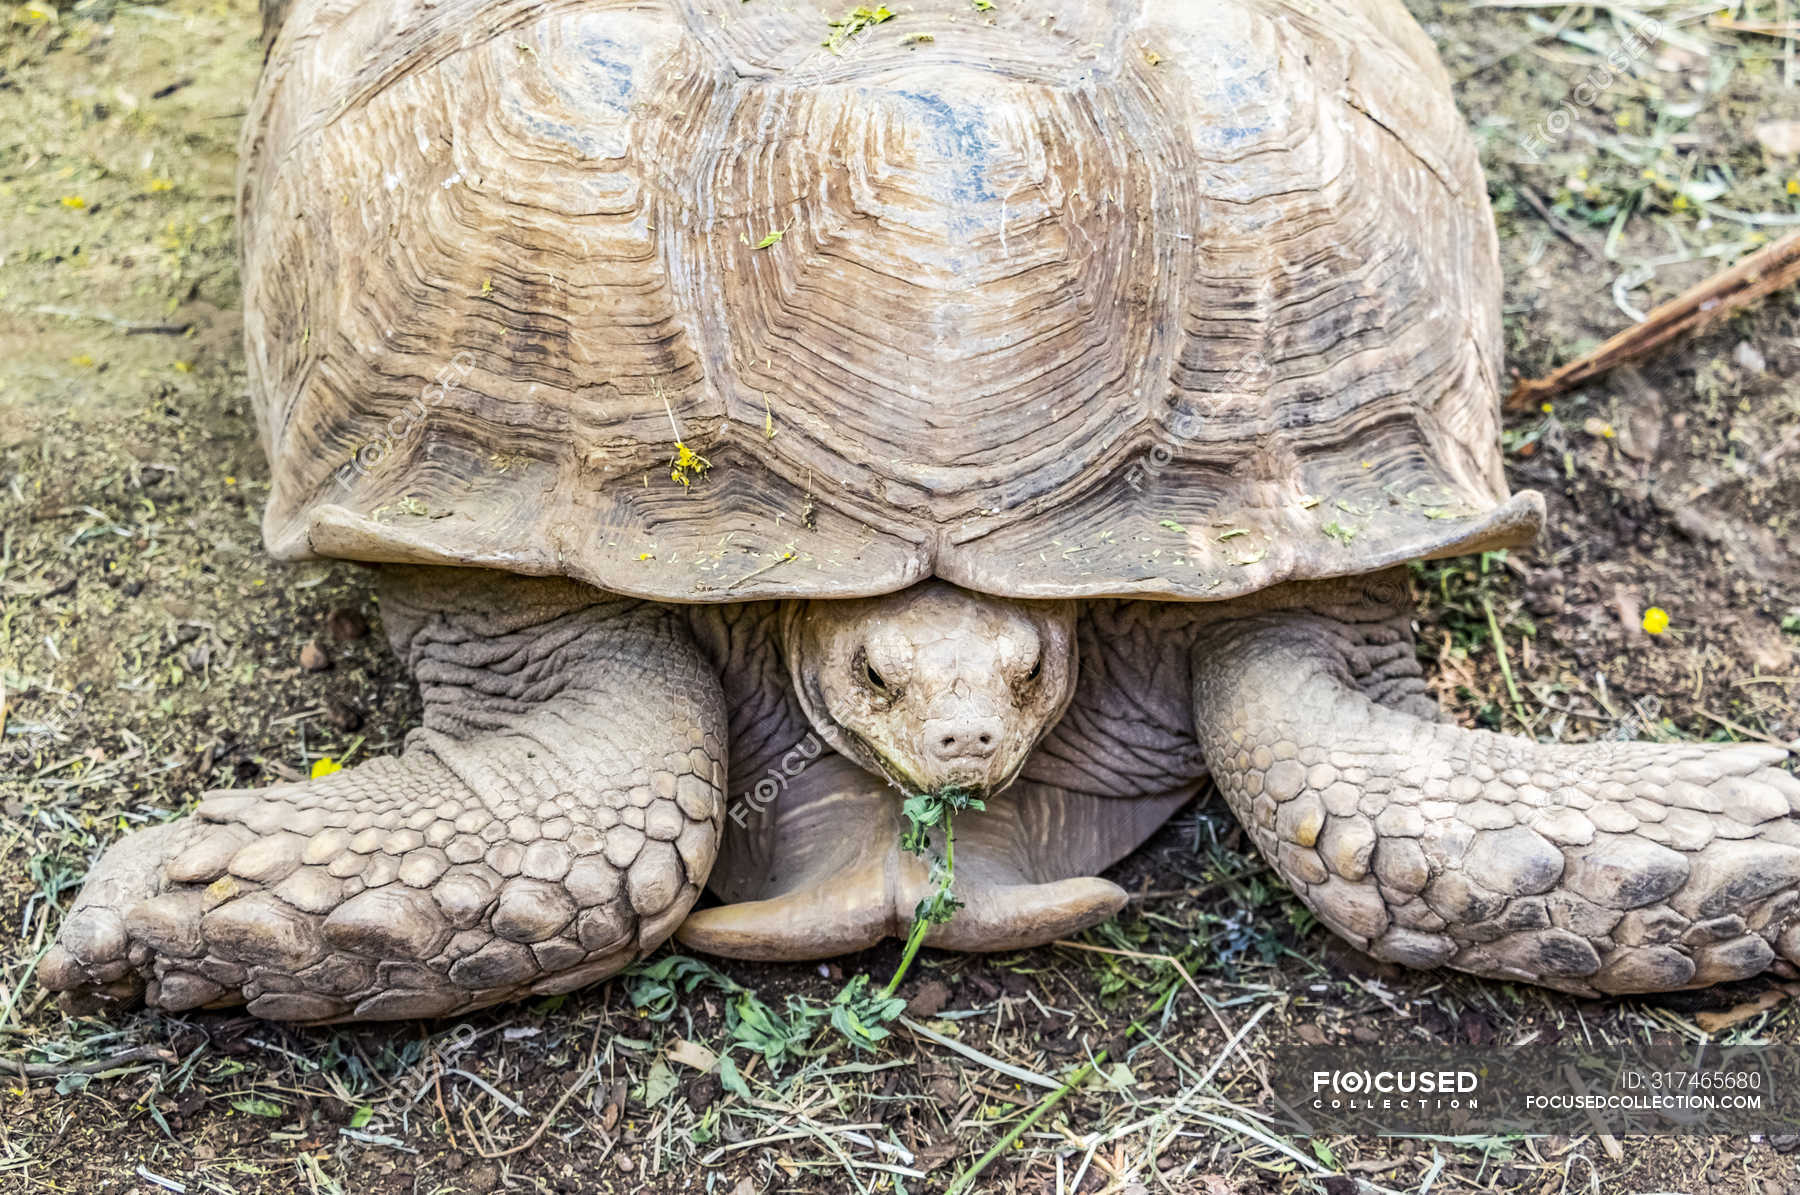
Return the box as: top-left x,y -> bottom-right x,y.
239,0 -> 1543,601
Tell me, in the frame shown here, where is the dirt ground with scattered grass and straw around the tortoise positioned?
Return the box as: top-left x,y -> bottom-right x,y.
0,0 -> 1800,1195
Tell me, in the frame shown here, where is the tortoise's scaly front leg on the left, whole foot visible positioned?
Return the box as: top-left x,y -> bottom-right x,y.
38,569 -> 725,1022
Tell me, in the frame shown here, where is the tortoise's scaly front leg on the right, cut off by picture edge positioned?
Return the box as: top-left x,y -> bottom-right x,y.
1193,575 -> 1800,995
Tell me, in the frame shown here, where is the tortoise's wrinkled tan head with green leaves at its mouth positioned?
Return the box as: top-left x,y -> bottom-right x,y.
783,581 -> 1076,794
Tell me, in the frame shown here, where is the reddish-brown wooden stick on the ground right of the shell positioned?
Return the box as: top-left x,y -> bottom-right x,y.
1507,232 -> 1800,410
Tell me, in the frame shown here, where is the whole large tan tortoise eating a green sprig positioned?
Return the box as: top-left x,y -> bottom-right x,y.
40,0 -> 1800,1022
